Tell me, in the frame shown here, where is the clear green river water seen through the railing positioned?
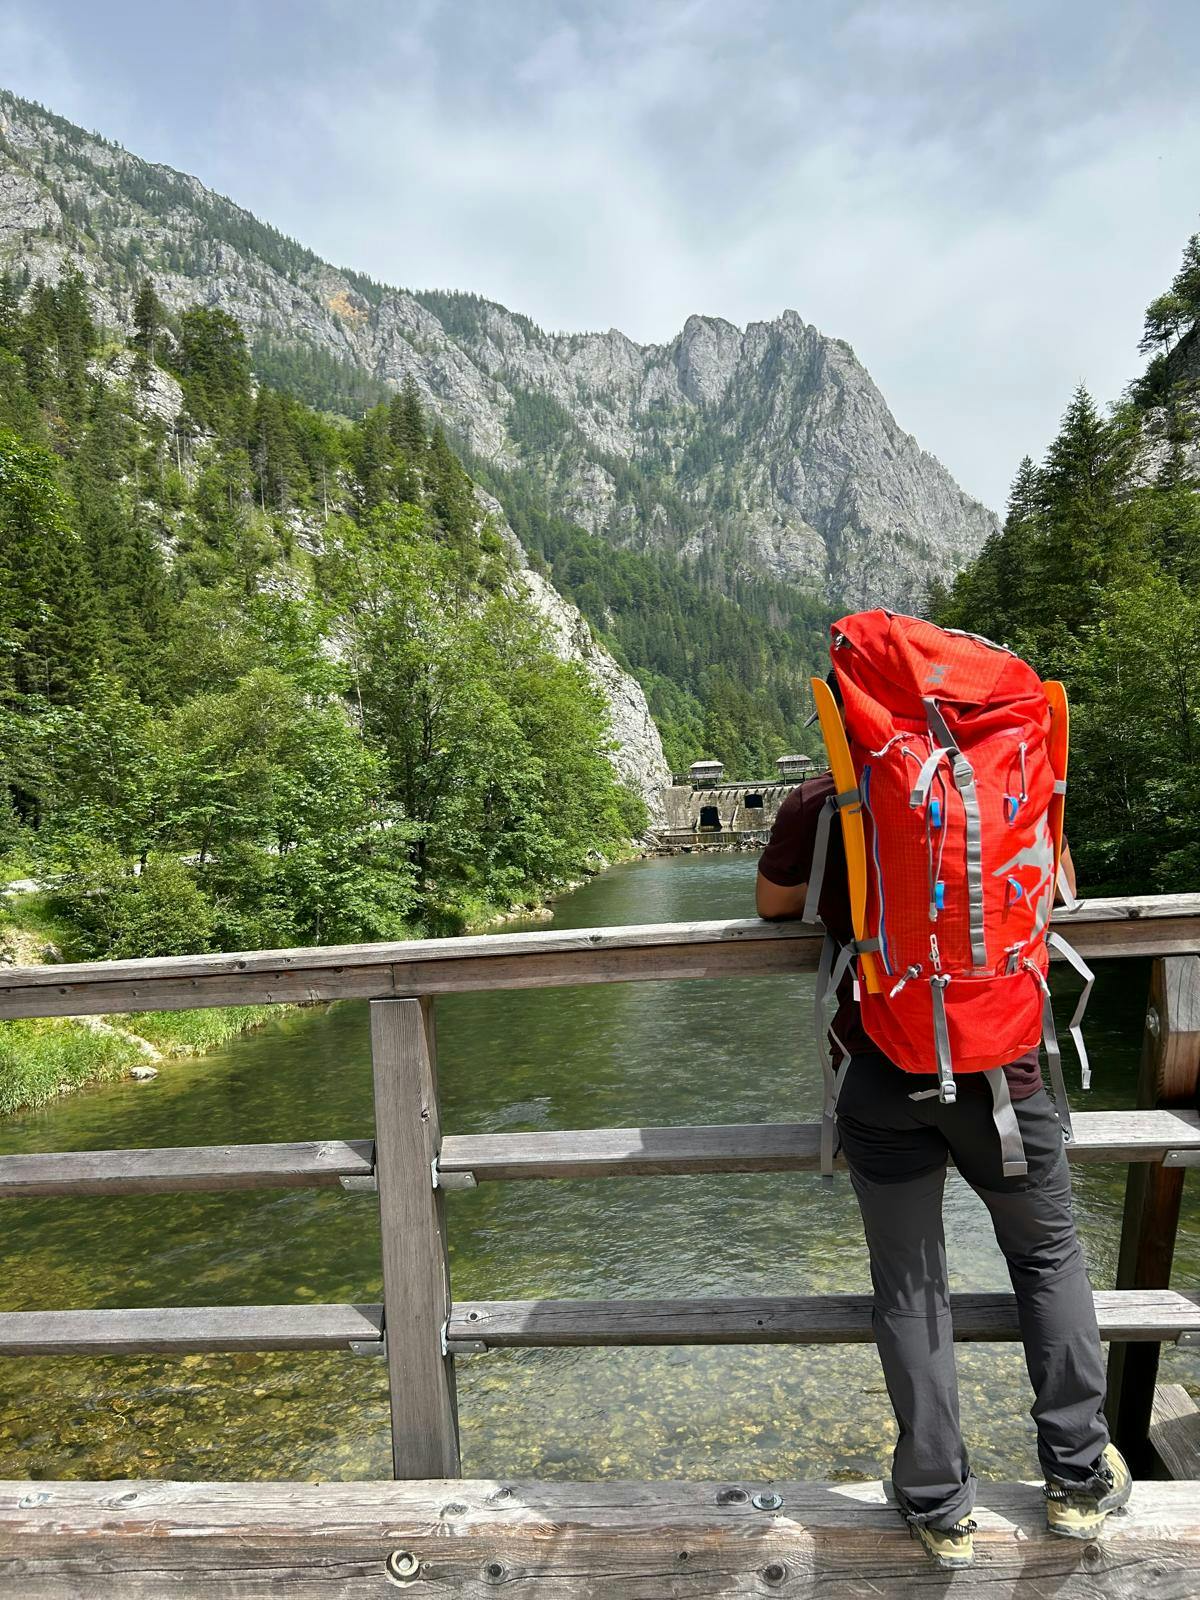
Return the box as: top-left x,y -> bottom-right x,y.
0,854 -> 1200,1478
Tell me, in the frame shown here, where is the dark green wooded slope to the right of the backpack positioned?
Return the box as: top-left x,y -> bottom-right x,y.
933,235 -> 1200,890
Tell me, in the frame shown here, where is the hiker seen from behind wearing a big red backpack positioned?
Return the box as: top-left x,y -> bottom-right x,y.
757,611 -> 1131,1570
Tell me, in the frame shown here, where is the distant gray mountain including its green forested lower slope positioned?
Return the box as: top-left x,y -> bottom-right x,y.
0,90 -> 995,778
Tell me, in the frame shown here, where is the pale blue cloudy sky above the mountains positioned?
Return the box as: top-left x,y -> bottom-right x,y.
0,0 -> 1200,507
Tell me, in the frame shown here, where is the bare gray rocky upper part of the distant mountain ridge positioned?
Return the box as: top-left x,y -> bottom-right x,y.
0,93 -> 995,606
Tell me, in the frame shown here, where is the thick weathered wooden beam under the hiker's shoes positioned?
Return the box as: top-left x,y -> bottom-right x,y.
0,1480 -> 1200,1600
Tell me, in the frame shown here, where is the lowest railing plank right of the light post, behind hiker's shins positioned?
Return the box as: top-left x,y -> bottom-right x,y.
448,1290 -> 1200,1349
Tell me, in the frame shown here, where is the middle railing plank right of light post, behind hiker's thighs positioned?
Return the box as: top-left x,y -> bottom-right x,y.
438,1110 -> 1200,1182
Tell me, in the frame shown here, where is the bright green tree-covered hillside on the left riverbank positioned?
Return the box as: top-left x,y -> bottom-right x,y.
0,269 -> 645,957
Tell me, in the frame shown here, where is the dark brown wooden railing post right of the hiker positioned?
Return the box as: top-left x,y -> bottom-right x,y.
1106,955 -> 1200,1477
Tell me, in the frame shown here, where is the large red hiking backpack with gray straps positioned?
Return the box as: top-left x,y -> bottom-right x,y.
805,611 -> 1091,1173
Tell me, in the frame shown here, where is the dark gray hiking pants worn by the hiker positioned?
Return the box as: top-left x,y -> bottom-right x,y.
837,1054 -> 1109,1528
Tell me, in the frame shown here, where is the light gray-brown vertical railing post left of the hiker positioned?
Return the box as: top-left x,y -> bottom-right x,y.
371,998 -> 459,1478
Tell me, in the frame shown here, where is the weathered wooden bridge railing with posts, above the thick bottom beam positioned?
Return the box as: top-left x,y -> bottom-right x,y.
0,894 -> 1200,1478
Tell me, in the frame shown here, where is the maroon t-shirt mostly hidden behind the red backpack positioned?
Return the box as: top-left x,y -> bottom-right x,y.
758,774 -> 1042,1099
